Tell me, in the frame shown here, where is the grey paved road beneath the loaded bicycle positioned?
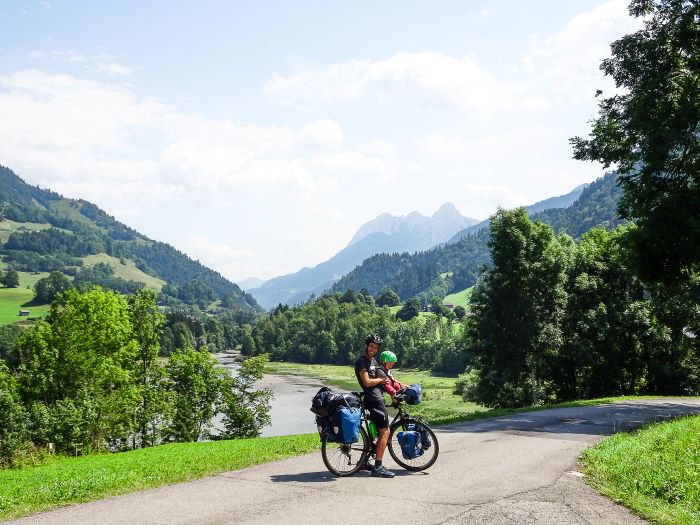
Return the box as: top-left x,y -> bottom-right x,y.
13,399 -> 700,525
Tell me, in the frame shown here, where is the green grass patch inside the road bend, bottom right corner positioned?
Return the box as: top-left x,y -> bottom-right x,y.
581,416 -> 700,525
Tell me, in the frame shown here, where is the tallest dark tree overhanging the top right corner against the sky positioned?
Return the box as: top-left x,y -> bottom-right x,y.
571,0 -> 700,282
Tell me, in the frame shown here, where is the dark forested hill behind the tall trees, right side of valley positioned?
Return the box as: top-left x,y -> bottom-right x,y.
332,173 -> 620,301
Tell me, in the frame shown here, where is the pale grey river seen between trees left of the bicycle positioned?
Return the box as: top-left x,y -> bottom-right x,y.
213,354 -> 348,437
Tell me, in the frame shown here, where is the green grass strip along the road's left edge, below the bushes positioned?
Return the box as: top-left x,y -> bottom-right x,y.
0,434 -> 320,519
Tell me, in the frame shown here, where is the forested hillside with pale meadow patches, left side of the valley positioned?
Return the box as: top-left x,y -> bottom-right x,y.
0,166 -> 261,317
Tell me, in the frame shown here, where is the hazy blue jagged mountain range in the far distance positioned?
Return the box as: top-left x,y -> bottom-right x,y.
248,203 -> 477,308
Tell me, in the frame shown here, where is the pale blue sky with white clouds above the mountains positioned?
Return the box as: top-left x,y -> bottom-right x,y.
0,0 -> 640,282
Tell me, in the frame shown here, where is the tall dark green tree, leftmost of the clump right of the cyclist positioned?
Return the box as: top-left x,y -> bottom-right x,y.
467,208 -> 573,406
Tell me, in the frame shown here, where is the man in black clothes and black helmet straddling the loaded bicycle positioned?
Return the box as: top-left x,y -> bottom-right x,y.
355,334 -> 396,478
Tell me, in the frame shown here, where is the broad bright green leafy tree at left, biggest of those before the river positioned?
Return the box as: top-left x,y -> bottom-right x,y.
17,288 -> 139,452
